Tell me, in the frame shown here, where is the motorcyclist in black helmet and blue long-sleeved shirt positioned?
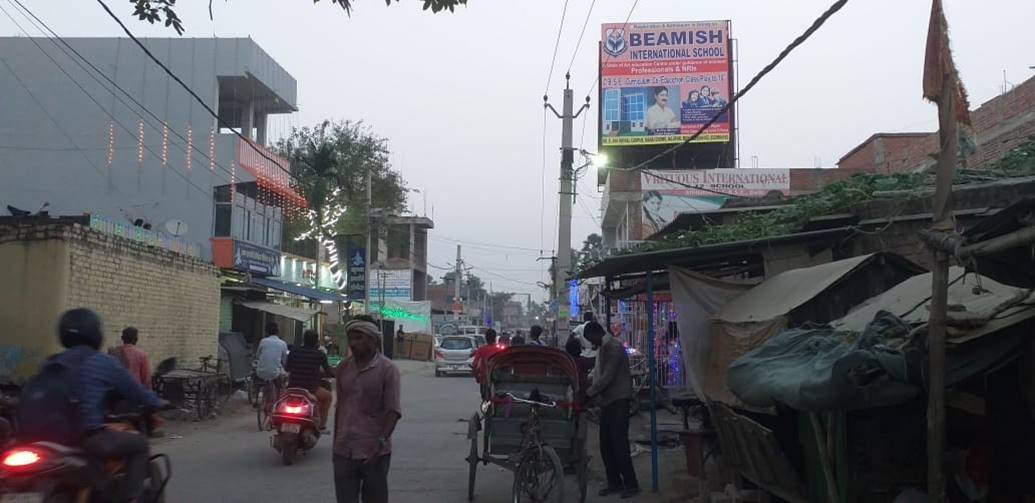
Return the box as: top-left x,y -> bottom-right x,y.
54,308 -> 168,501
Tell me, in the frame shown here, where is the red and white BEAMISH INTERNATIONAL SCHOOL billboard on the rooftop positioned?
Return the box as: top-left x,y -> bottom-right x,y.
600,21 -> 733,147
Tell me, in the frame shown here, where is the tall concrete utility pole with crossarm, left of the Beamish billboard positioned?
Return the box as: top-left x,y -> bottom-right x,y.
542,73 -> 589,344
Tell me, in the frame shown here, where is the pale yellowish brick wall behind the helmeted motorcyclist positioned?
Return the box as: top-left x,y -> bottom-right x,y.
66,226 -> 219,367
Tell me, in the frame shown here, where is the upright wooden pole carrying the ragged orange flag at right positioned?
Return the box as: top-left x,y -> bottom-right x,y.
927,68 -> 958,503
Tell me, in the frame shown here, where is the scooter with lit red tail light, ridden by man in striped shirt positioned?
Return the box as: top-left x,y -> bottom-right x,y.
270,388 -> 320,465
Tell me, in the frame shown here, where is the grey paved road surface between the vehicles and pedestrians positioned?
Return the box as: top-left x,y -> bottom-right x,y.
155,362 -> 594,503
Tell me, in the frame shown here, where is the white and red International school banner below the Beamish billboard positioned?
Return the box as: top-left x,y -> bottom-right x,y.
640,169 -> 791,237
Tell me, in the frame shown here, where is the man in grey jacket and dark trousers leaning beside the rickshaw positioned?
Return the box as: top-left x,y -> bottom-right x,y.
583,322 -> 640,499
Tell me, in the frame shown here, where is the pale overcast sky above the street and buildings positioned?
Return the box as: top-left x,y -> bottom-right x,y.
0,0 -> 1035,298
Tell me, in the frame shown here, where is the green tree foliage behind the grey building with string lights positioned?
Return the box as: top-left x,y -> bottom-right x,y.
274,120 -> 407,249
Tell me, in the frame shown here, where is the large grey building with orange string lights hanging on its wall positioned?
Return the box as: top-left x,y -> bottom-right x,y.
0,37 -> 300,262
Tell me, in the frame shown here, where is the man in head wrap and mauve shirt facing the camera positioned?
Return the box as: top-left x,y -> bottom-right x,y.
333,320 -> 403,503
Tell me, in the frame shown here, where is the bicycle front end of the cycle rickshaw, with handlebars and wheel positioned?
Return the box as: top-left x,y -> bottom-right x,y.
504,389 -> 564,503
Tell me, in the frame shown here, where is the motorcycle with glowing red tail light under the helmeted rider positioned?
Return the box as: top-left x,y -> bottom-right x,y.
0,411 -> 172,503
